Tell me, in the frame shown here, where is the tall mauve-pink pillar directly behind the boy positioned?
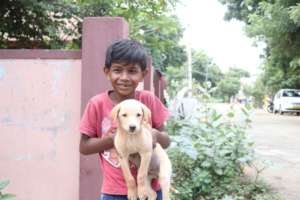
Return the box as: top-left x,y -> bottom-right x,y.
80,17 -> 128,200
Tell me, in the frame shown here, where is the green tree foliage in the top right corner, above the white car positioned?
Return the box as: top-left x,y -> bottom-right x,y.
219,0 -> 300,93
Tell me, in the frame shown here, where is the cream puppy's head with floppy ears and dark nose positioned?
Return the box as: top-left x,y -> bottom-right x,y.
110,99 -> 151,134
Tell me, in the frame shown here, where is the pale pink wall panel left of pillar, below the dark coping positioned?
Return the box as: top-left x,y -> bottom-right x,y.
0,58 -> 81,200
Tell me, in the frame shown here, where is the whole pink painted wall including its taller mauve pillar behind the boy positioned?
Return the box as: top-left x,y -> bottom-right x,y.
0,17 -> 162,200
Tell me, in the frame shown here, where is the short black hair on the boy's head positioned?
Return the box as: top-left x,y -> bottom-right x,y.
105,39 -> 147,70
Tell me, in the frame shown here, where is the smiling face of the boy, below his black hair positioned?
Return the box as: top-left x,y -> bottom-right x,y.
104,63 -> 148,99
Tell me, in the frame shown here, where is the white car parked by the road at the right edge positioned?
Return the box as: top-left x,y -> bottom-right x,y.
273,89 -> 300,115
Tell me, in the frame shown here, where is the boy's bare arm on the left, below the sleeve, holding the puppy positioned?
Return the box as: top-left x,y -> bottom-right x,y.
79,134 -> 114,155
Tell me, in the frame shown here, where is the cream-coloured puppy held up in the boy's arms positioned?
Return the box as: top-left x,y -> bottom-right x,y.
111,99 -> 172,200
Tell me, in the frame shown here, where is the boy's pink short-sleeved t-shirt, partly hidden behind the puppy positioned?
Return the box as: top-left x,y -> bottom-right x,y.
80,91 -> 169,195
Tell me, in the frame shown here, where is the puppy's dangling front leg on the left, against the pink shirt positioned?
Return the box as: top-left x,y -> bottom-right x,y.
119,157 -> 137,200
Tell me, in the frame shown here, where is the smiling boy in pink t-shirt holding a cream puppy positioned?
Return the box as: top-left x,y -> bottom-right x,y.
80,40 -> 170,200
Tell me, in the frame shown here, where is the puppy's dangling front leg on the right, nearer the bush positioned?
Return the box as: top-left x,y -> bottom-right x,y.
137,151 -> 152,200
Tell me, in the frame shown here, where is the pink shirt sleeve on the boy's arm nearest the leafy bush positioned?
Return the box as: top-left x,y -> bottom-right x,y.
151,95 -> 170,128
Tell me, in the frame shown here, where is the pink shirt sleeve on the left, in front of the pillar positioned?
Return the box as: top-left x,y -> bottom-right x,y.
79,101 -> 98,137
